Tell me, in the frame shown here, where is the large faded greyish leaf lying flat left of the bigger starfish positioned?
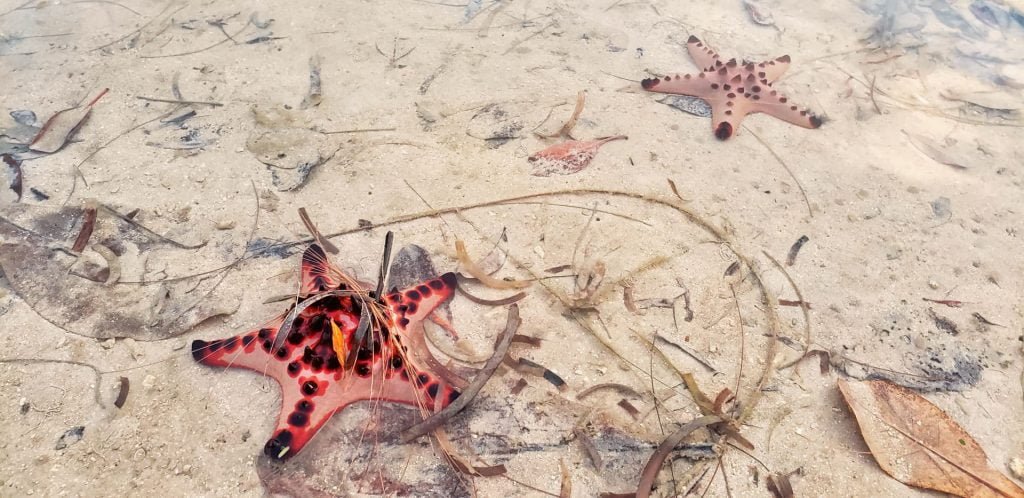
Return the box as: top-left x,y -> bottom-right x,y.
0,204 -> 239,340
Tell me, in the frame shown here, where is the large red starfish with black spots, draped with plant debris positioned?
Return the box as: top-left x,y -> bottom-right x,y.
191,245 -> 466,460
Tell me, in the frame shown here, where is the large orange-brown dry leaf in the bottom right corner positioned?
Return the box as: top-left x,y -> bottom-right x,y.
839,380 -> 1024,498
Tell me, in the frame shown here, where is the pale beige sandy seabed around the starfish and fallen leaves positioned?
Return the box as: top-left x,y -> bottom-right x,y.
0,0 -> 1024,497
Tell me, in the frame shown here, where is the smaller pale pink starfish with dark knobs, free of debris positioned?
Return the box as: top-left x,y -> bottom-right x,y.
640,36 -> 821,140
